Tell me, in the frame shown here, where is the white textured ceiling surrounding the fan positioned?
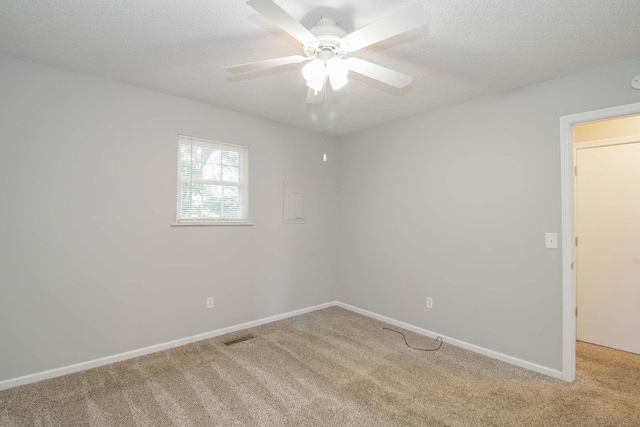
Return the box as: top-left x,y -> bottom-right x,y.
0,0 -> 640,135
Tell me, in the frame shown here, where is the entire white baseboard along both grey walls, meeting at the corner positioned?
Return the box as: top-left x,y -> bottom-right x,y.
0,301 -> 562,391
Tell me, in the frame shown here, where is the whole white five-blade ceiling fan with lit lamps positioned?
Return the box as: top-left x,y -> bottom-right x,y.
226,0 -> 429,103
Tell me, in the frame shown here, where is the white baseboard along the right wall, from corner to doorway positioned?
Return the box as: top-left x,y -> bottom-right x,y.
336,302 -> 562,379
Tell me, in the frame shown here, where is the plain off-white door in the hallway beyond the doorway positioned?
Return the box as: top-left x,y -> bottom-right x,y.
576,143 -> 640,354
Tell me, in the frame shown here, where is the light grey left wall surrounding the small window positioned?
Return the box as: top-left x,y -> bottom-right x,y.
0,56 -> 337,381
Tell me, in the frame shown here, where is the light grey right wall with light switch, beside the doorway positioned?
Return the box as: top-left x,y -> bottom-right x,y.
338,59 -> 640,370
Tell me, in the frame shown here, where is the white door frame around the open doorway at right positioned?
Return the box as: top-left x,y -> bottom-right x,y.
560,103 -> 640,381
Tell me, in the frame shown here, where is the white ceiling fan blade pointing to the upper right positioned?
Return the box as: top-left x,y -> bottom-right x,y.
342,3 -> 430,52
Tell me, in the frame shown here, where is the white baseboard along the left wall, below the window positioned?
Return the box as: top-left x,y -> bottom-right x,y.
0,302 -> 336,391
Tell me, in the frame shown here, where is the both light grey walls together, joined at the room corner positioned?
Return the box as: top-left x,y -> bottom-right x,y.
0,51 -> 640,381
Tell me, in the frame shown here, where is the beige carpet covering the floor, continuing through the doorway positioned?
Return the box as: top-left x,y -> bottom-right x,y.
0,307 -> 640,427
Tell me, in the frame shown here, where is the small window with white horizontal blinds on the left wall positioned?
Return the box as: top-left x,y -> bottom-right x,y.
177,135 -> 249,224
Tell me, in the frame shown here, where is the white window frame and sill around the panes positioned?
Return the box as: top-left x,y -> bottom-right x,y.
172,134 -> 252,225
